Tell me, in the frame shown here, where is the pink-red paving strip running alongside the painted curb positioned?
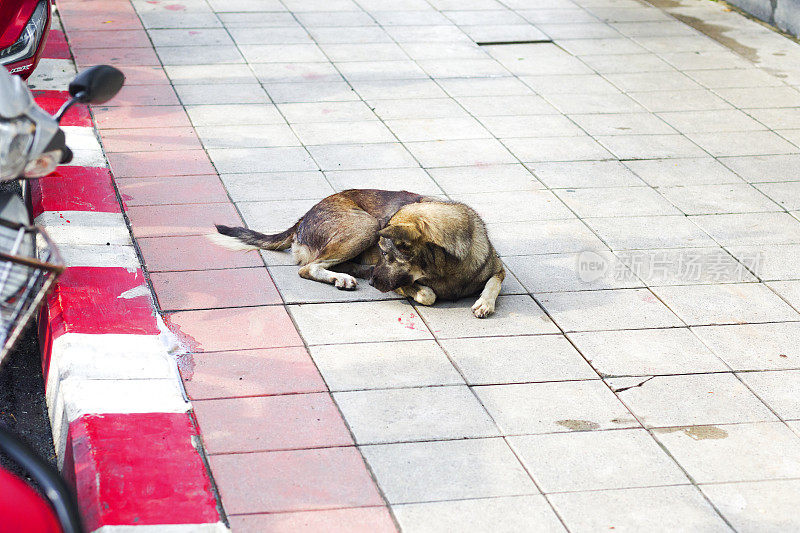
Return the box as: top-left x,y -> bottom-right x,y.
49,0 -> 396,532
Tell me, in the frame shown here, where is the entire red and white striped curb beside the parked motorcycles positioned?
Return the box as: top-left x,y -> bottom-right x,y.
30,17 -> 227,533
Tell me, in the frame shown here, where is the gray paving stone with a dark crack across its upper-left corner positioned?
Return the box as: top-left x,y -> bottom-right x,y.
608,373 -> 777,428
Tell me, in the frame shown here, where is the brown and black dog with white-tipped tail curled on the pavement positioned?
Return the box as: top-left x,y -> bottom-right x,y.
211,189 -> 505,318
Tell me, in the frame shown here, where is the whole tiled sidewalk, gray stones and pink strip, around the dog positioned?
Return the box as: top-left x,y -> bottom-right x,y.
61,0 -> 800,532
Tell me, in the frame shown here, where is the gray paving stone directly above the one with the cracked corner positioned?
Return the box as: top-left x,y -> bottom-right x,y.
568,328 -> 728,377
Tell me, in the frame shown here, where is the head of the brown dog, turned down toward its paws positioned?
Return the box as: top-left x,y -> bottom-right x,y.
369,223 -> 425,292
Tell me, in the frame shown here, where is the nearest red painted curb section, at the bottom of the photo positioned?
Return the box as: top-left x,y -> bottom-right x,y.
64,413 -> 219,531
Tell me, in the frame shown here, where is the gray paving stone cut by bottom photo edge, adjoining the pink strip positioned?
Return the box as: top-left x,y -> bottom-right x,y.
392,496 -> 565,533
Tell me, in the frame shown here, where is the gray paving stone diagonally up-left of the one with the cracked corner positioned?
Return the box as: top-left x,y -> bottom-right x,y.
440,335 -> 598,385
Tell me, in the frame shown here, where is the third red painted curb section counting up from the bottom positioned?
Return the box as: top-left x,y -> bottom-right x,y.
31,167 -> 120,217
